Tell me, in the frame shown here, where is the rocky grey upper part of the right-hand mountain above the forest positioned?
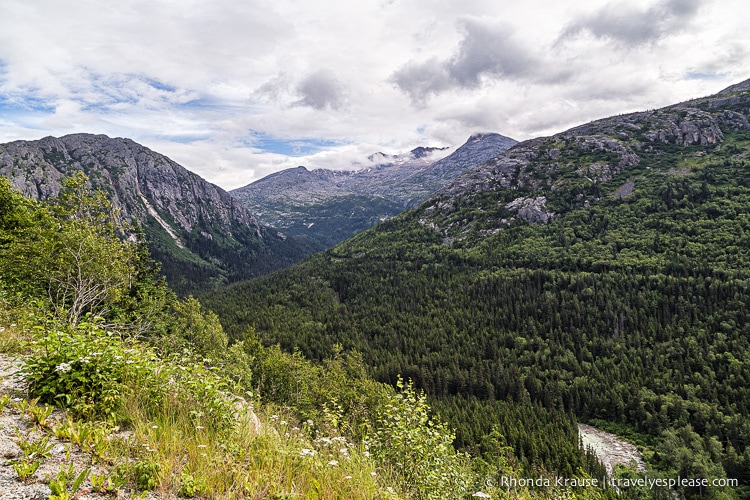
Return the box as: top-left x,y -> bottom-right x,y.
419,80 -> 750,243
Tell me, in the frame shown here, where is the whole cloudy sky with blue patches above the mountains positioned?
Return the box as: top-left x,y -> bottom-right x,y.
0,0 -> 750,189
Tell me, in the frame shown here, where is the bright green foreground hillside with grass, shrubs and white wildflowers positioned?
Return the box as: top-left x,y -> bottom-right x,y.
0,172 -> 613,500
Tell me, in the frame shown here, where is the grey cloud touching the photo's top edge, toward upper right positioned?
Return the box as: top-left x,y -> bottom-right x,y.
560,0 -> 702,47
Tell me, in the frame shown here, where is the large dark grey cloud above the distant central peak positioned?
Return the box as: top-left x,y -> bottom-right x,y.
391,16 -> 546,106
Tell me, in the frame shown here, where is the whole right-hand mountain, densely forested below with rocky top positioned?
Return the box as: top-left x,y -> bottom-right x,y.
207,80 -> 750,498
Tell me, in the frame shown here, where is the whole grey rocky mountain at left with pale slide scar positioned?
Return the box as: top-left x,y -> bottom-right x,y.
0,134 -> 318,293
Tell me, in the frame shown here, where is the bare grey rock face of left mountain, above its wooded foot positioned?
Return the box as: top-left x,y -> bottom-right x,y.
0,134 -> 260,236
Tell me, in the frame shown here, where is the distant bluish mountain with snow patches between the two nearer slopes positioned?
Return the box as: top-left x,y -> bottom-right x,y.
231,134 -> 516,249
